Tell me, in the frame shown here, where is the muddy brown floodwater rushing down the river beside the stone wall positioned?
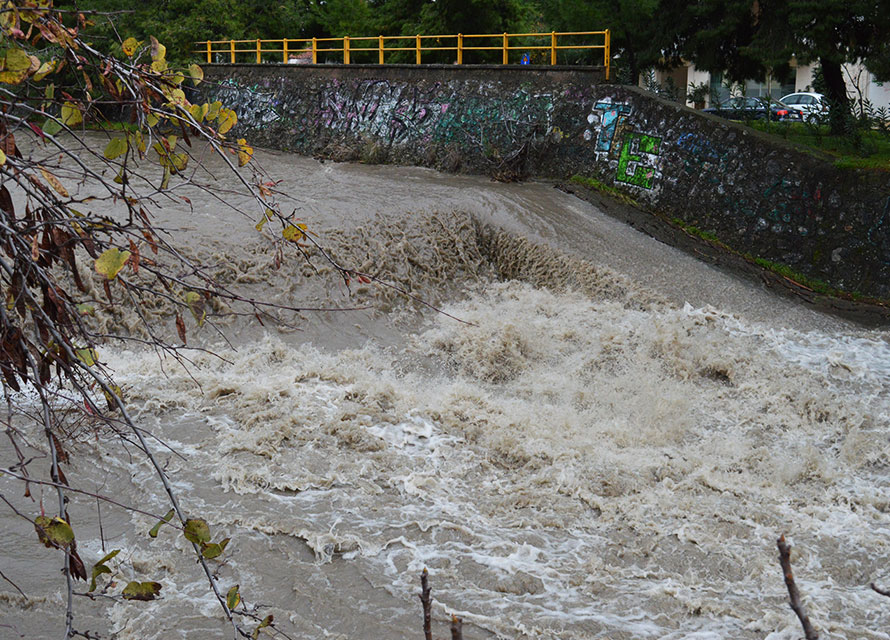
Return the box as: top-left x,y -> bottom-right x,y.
0,146 -> 890,640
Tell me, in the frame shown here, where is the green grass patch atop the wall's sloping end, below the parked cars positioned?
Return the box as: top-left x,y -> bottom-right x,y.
748,121 -> 890,171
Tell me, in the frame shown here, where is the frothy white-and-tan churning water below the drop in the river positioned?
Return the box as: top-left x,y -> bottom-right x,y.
74,282 -> 890,639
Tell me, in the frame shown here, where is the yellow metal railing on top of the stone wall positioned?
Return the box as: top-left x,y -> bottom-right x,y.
195,29 -> 612,80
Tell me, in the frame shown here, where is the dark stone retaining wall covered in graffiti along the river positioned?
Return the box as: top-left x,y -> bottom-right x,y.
202,65 -> 890,298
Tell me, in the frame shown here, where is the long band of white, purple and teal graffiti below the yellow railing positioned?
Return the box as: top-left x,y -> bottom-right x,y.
212,79 -> 554,158
